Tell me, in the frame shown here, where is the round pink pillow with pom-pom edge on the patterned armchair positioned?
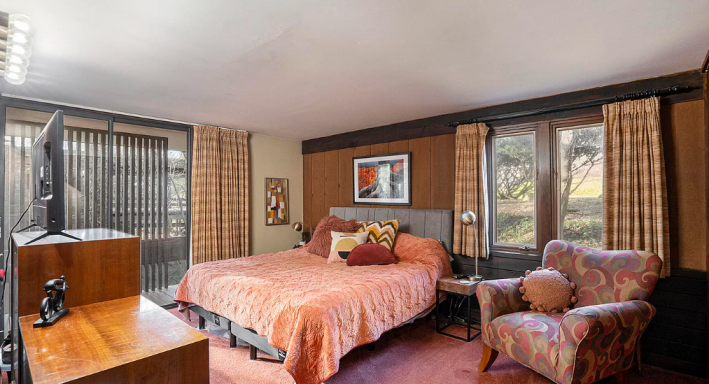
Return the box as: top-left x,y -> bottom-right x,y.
519,267 -> 578,312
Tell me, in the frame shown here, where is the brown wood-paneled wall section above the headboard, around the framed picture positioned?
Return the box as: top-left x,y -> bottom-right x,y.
303,134 -> 455,227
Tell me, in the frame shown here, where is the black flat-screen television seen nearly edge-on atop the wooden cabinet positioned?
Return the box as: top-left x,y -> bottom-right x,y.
32,111 -> 66,233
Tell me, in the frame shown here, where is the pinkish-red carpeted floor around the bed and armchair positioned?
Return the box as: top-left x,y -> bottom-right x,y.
170,309 -> 709,384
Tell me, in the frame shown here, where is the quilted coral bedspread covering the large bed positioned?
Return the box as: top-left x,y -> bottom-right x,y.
175,233 -> 451,384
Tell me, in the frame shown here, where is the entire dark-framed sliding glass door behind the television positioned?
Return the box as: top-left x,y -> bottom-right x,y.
0,97 -> 190,304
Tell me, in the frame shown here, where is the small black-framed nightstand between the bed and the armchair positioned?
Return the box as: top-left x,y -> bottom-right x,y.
436,277 -> 480,342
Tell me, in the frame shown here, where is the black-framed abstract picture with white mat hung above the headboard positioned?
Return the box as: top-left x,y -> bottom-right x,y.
352,152 -> 411,205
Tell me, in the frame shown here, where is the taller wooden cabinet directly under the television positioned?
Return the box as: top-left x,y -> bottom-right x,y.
12,229 -> 140,316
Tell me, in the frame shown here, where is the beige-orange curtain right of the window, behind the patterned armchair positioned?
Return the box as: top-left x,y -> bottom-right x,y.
603,97 -> 670,277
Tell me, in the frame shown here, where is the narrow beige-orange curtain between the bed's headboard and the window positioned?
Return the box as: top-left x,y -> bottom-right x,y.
453,123 -> 488,257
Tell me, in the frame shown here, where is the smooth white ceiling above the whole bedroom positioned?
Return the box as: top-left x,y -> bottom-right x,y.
0,0 -> 709,139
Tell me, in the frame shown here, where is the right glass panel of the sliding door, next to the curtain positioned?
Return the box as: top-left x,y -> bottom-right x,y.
112,123 -> 188,290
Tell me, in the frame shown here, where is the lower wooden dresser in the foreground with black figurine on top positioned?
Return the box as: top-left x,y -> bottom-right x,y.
20,292 -> 209,384
